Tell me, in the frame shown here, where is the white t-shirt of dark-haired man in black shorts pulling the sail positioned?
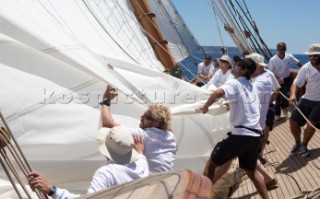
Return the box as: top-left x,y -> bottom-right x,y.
220,77 -> 262,137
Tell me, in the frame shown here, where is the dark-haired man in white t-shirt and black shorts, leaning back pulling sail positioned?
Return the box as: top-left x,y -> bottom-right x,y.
198,59 -> 269,199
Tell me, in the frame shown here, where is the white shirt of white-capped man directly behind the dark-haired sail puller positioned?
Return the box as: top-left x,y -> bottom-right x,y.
251,70 -> 280,129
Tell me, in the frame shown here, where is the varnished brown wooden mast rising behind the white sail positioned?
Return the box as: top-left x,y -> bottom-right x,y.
130,0 -> 179,72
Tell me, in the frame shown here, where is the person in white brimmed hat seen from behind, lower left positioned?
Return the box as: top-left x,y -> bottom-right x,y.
28,126 -> 150,199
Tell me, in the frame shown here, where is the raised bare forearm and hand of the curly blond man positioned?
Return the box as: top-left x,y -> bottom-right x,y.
101,86 -> 120,128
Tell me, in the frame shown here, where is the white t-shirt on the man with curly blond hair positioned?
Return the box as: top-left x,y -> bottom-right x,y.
131,128 -> 177,173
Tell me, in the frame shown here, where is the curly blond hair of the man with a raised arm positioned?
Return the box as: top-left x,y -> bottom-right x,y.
149,104 -> 171,131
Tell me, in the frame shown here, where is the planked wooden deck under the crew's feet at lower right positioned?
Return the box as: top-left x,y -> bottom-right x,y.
229,118 -> 320,199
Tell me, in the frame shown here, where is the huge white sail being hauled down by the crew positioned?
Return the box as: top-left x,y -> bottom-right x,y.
0,0 -> 230,197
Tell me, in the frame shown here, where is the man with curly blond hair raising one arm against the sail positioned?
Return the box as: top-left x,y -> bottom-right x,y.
101,86 -> 177,173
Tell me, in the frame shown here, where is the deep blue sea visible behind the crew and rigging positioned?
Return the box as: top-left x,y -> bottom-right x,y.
180,52 -> 310,80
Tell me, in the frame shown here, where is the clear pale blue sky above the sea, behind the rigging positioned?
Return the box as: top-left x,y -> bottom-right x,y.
172,0 -> 320,54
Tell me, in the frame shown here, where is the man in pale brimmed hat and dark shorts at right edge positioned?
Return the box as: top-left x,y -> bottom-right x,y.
289,43 -> 320,157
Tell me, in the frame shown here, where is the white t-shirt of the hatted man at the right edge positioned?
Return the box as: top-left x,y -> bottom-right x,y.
293,62 -> 320,102
